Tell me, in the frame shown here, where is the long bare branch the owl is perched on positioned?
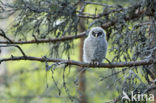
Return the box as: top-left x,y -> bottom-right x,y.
0,56 -> 156,68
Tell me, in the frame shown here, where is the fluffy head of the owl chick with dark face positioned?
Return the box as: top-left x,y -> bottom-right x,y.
89,27 -> 106,38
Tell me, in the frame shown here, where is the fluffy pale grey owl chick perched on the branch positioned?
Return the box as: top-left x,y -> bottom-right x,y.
83,27 -> 107,64
